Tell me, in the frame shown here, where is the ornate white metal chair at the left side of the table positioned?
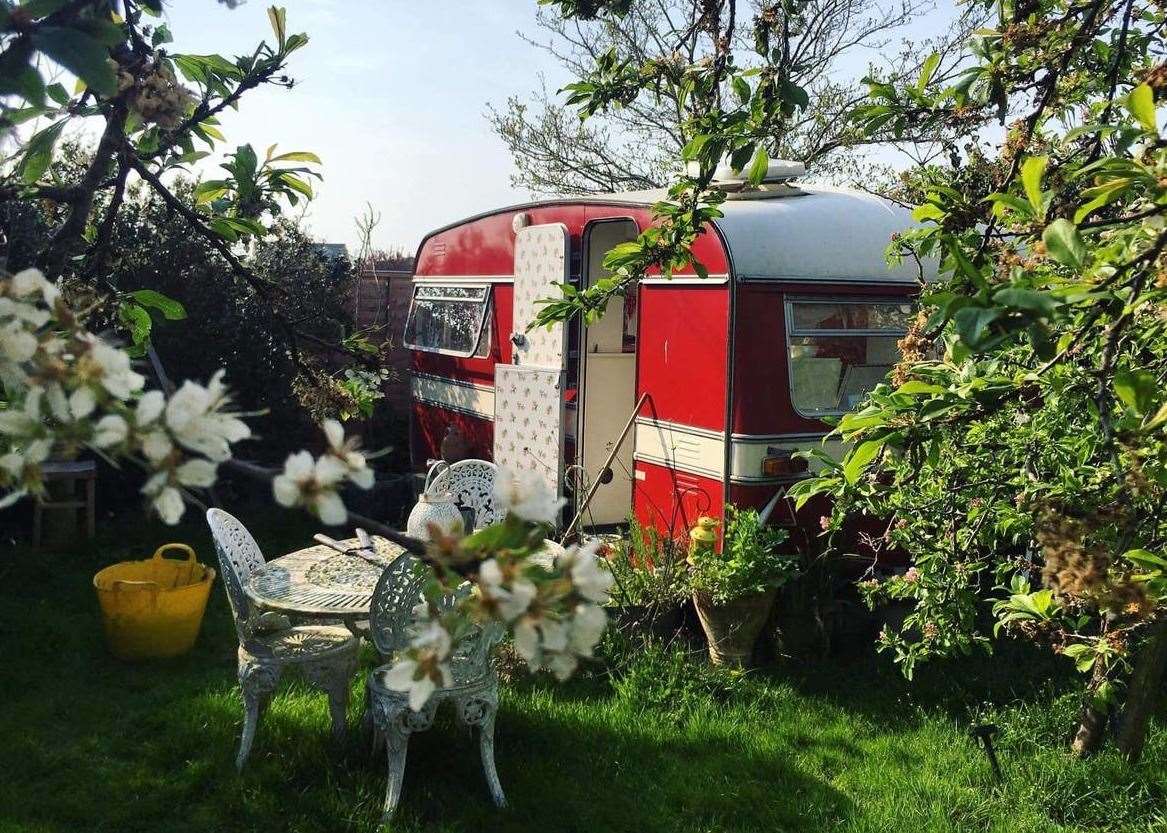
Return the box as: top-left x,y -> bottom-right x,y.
207,509 -> 361,771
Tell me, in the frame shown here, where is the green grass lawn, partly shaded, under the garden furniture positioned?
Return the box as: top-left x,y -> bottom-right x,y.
0,506 -> 1167,833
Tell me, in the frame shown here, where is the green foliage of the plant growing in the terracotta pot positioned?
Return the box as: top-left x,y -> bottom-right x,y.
690,504 -> 799,604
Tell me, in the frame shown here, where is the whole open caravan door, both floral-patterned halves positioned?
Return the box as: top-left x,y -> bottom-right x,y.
495,223 -> 569,515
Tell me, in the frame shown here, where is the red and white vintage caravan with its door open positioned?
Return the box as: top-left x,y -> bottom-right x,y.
404,169 -> 918,546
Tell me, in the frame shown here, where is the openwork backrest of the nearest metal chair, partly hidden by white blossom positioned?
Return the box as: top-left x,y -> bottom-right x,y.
369,554 -> 502,684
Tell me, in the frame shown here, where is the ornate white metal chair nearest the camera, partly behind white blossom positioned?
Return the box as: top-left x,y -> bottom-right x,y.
366,555 -> 506,819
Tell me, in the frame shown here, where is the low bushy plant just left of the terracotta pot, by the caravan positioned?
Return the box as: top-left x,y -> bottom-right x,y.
607,517 -> 689,639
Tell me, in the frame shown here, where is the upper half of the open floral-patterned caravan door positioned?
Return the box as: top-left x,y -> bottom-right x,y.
511,223 -> 569,369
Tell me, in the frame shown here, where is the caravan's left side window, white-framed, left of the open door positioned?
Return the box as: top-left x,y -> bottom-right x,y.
403,284 -> 490,357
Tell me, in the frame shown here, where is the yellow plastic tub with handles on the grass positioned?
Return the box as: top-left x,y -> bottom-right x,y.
93,544 -> 215,660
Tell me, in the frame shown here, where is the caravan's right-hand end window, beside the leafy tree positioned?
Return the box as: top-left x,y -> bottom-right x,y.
787,301 -> 914,417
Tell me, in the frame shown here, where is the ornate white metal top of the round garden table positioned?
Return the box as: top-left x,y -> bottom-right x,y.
244,536 -> 405,618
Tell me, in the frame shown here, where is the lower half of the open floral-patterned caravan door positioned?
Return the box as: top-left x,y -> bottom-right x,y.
495,364 -> 564,495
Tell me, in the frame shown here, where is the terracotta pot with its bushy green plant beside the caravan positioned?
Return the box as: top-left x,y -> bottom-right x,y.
689,505 -> 798,665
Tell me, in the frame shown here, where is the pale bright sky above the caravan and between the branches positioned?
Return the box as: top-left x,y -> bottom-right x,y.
157,0 -> 943,253
